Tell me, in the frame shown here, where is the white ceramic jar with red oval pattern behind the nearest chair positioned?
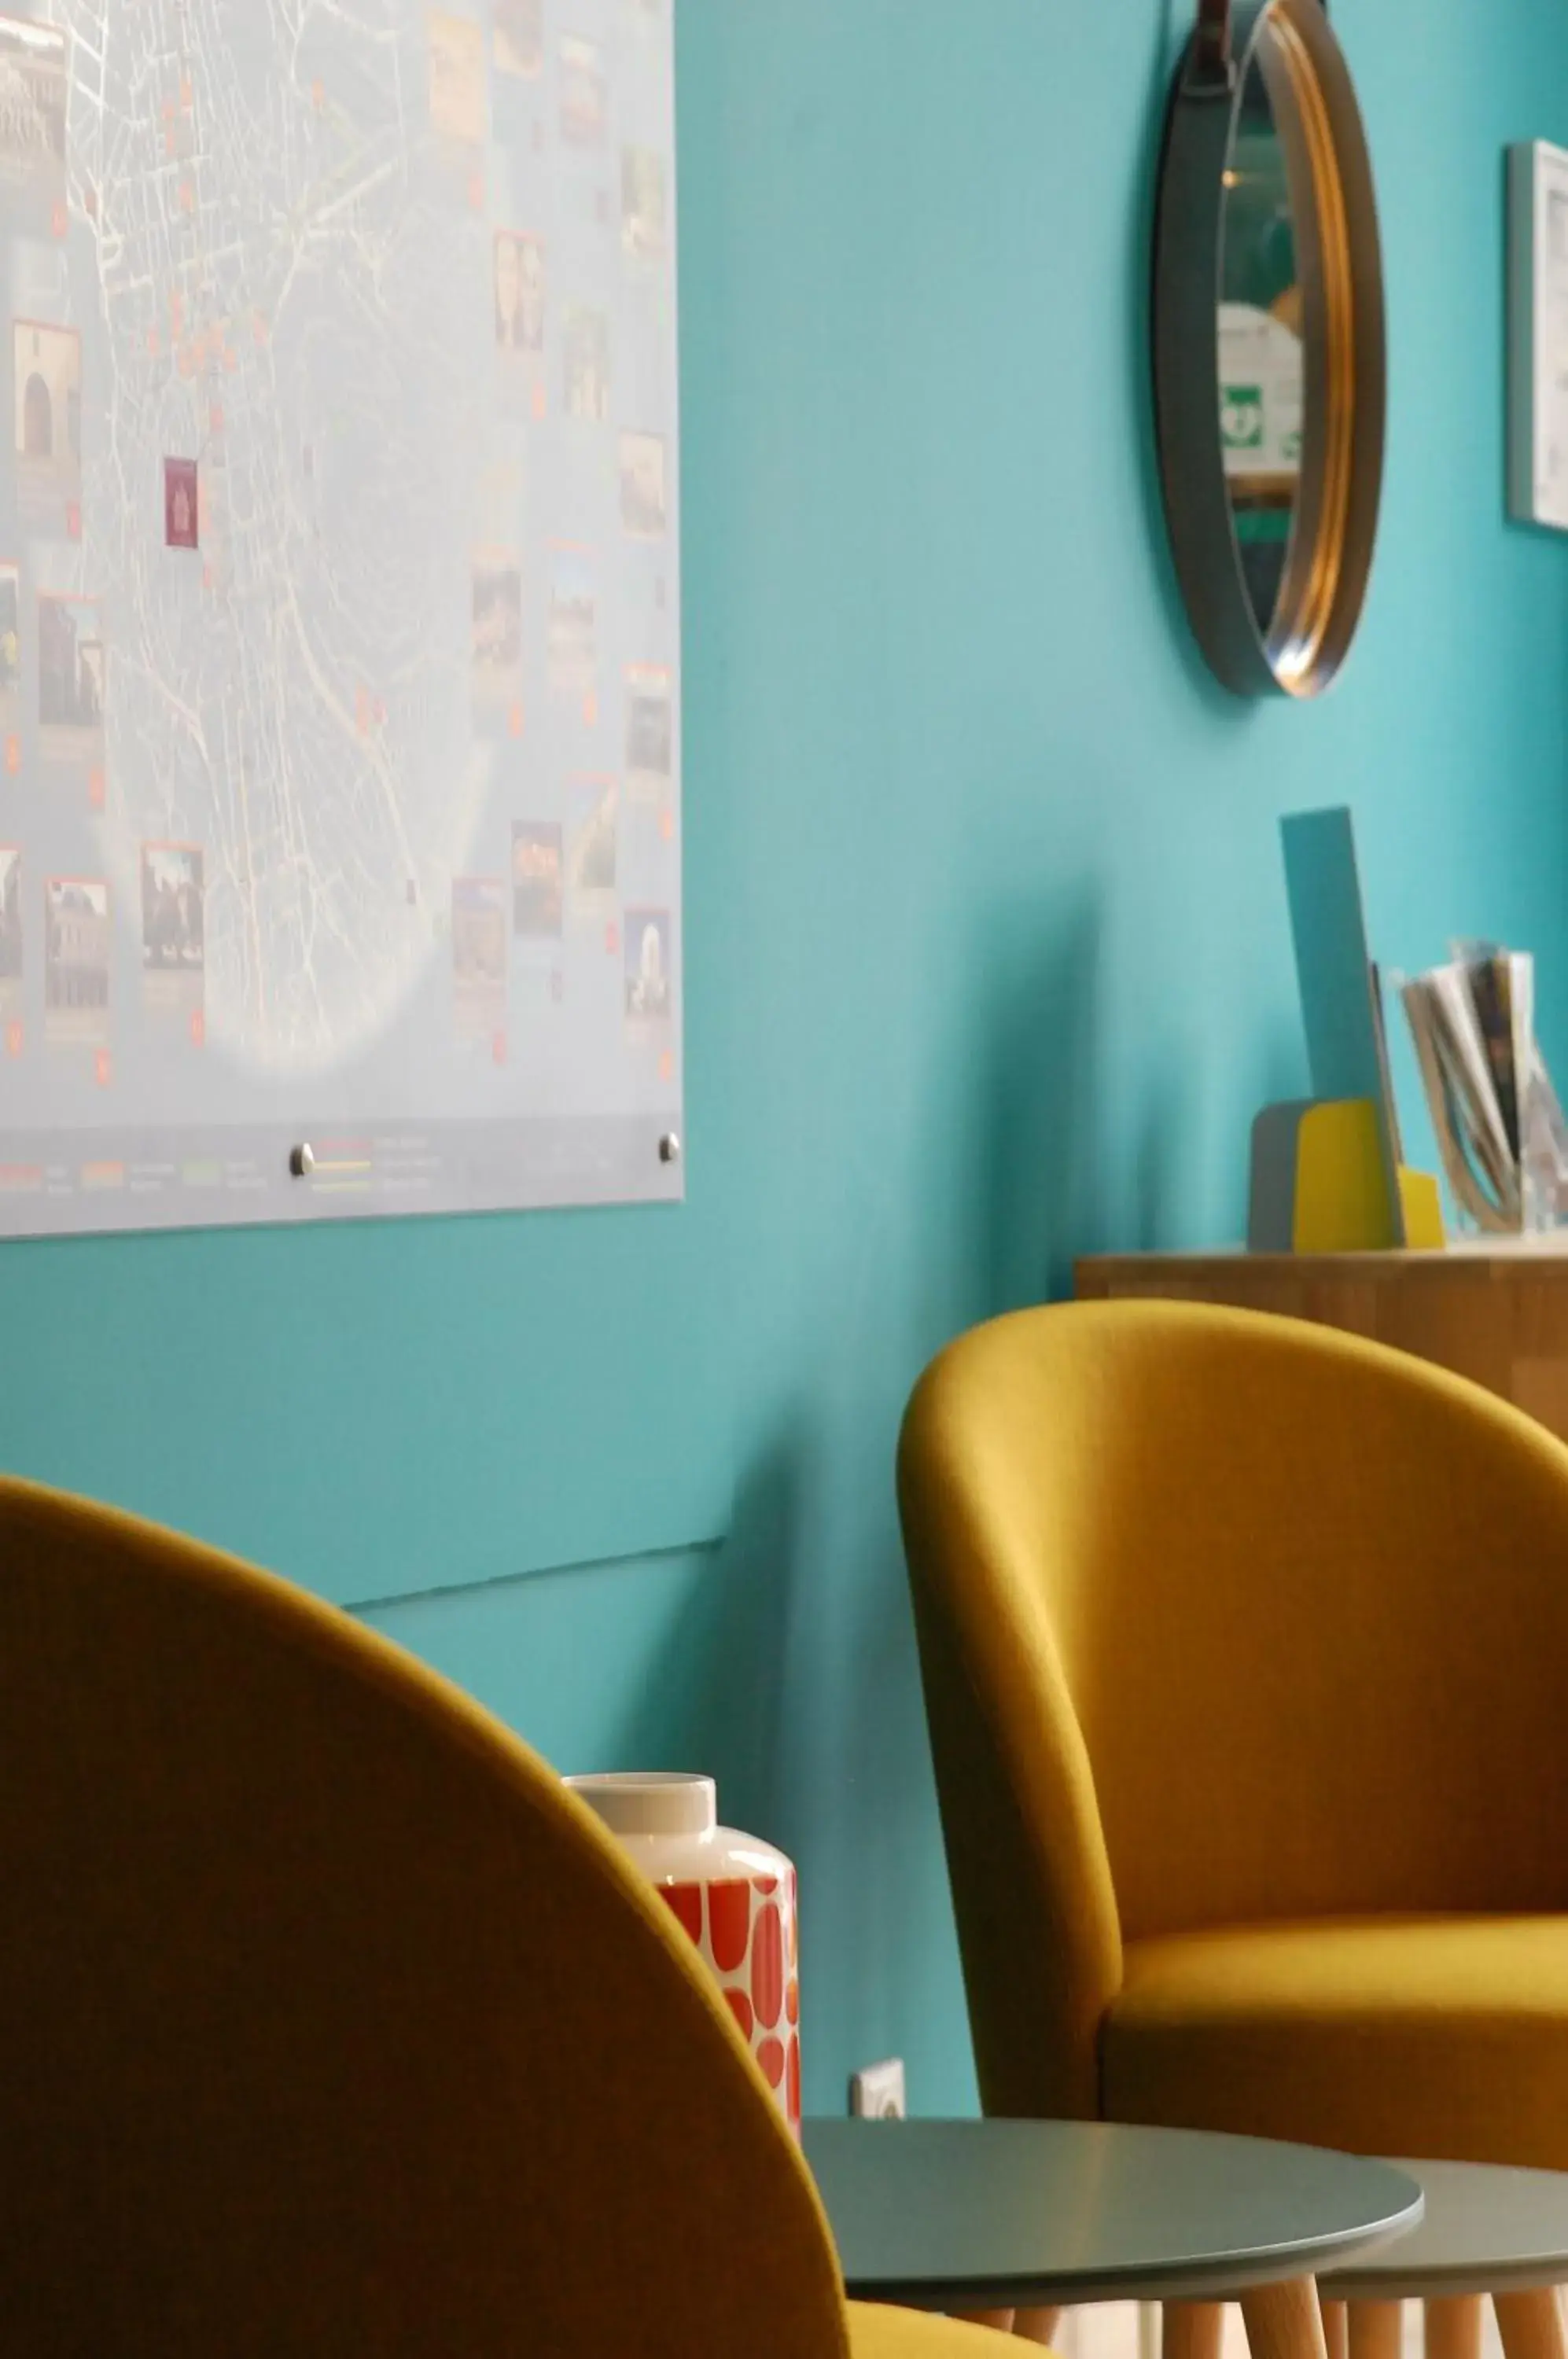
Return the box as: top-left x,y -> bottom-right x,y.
566,1772 -> 799,2135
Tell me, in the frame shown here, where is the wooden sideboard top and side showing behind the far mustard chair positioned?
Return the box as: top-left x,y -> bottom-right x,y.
1077,1238 -> 1568,1441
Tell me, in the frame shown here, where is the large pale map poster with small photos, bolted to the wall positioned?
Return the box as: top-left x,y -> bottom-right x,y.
0,0 -> 682,1236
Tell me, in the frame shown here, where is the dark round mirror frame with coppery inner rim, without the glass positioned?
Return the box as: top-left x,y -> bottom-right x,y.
1153,0 -> 1386,698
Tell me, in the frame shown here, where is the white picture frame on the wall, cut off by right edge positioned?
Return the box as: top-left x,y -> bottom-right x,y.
1509,139 -> 1568,533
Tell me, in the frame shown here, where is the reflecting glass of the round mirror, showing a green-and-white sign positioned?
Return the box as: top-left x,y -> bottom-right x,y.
1219,54 -> 1304,639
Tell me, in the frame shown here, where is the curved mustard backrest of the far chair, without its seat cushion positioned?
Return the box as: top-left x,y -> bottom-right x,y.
900,1302 -> 1568,2114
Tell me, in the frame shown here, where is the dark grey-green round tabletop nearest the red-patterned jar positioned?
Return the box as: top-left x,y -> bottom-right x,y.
804,2121 -> 1422,2309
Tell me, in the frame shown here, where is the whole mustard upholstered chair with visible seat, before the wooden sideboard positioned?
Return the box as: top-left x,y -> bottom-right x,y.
900,1302 -> 1568,2359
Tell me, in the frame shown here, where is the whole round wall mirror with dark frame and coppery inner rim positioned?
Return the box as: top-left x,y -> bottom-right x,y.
1153,0 -> 1386,696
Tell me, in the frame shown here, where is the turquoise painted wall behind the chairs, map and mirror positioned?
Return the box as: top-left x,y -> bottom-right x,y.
0,0 -> 1568,2111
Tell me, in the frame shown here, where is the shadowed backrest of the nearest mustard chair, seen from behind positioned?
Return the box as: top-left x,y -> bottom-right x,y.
0,1484 -> 846,2359
